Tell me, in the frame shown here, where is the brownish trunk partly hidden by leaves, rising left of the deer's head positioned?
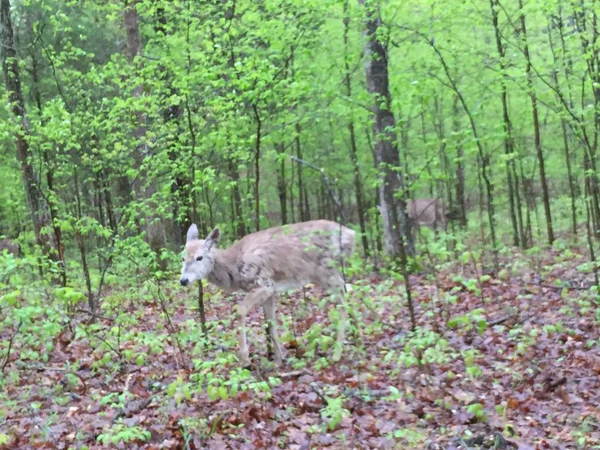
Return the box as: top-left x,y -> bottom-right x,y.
124,0 -> 166,270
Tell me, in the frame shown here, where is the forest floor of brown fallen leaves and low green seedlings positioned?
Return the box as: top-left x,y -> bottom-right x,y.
0,247 -> 600,449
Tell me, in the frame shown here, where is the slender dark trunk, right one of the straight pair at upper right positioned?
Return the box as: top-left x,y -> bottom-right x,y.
519,0 -> 554,245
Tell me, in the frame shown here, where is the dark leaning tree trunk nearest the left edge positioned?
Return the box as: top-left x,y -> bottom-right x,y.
0,0 -> 58,261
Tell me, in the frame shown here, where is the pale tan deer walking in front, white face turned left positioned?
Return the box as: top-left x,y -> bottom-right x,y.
179,220 -> 355,367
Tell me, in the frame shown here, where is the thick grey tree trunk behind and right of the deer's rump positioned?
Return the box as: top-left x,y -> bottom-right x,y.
359,0 -> 414,261
